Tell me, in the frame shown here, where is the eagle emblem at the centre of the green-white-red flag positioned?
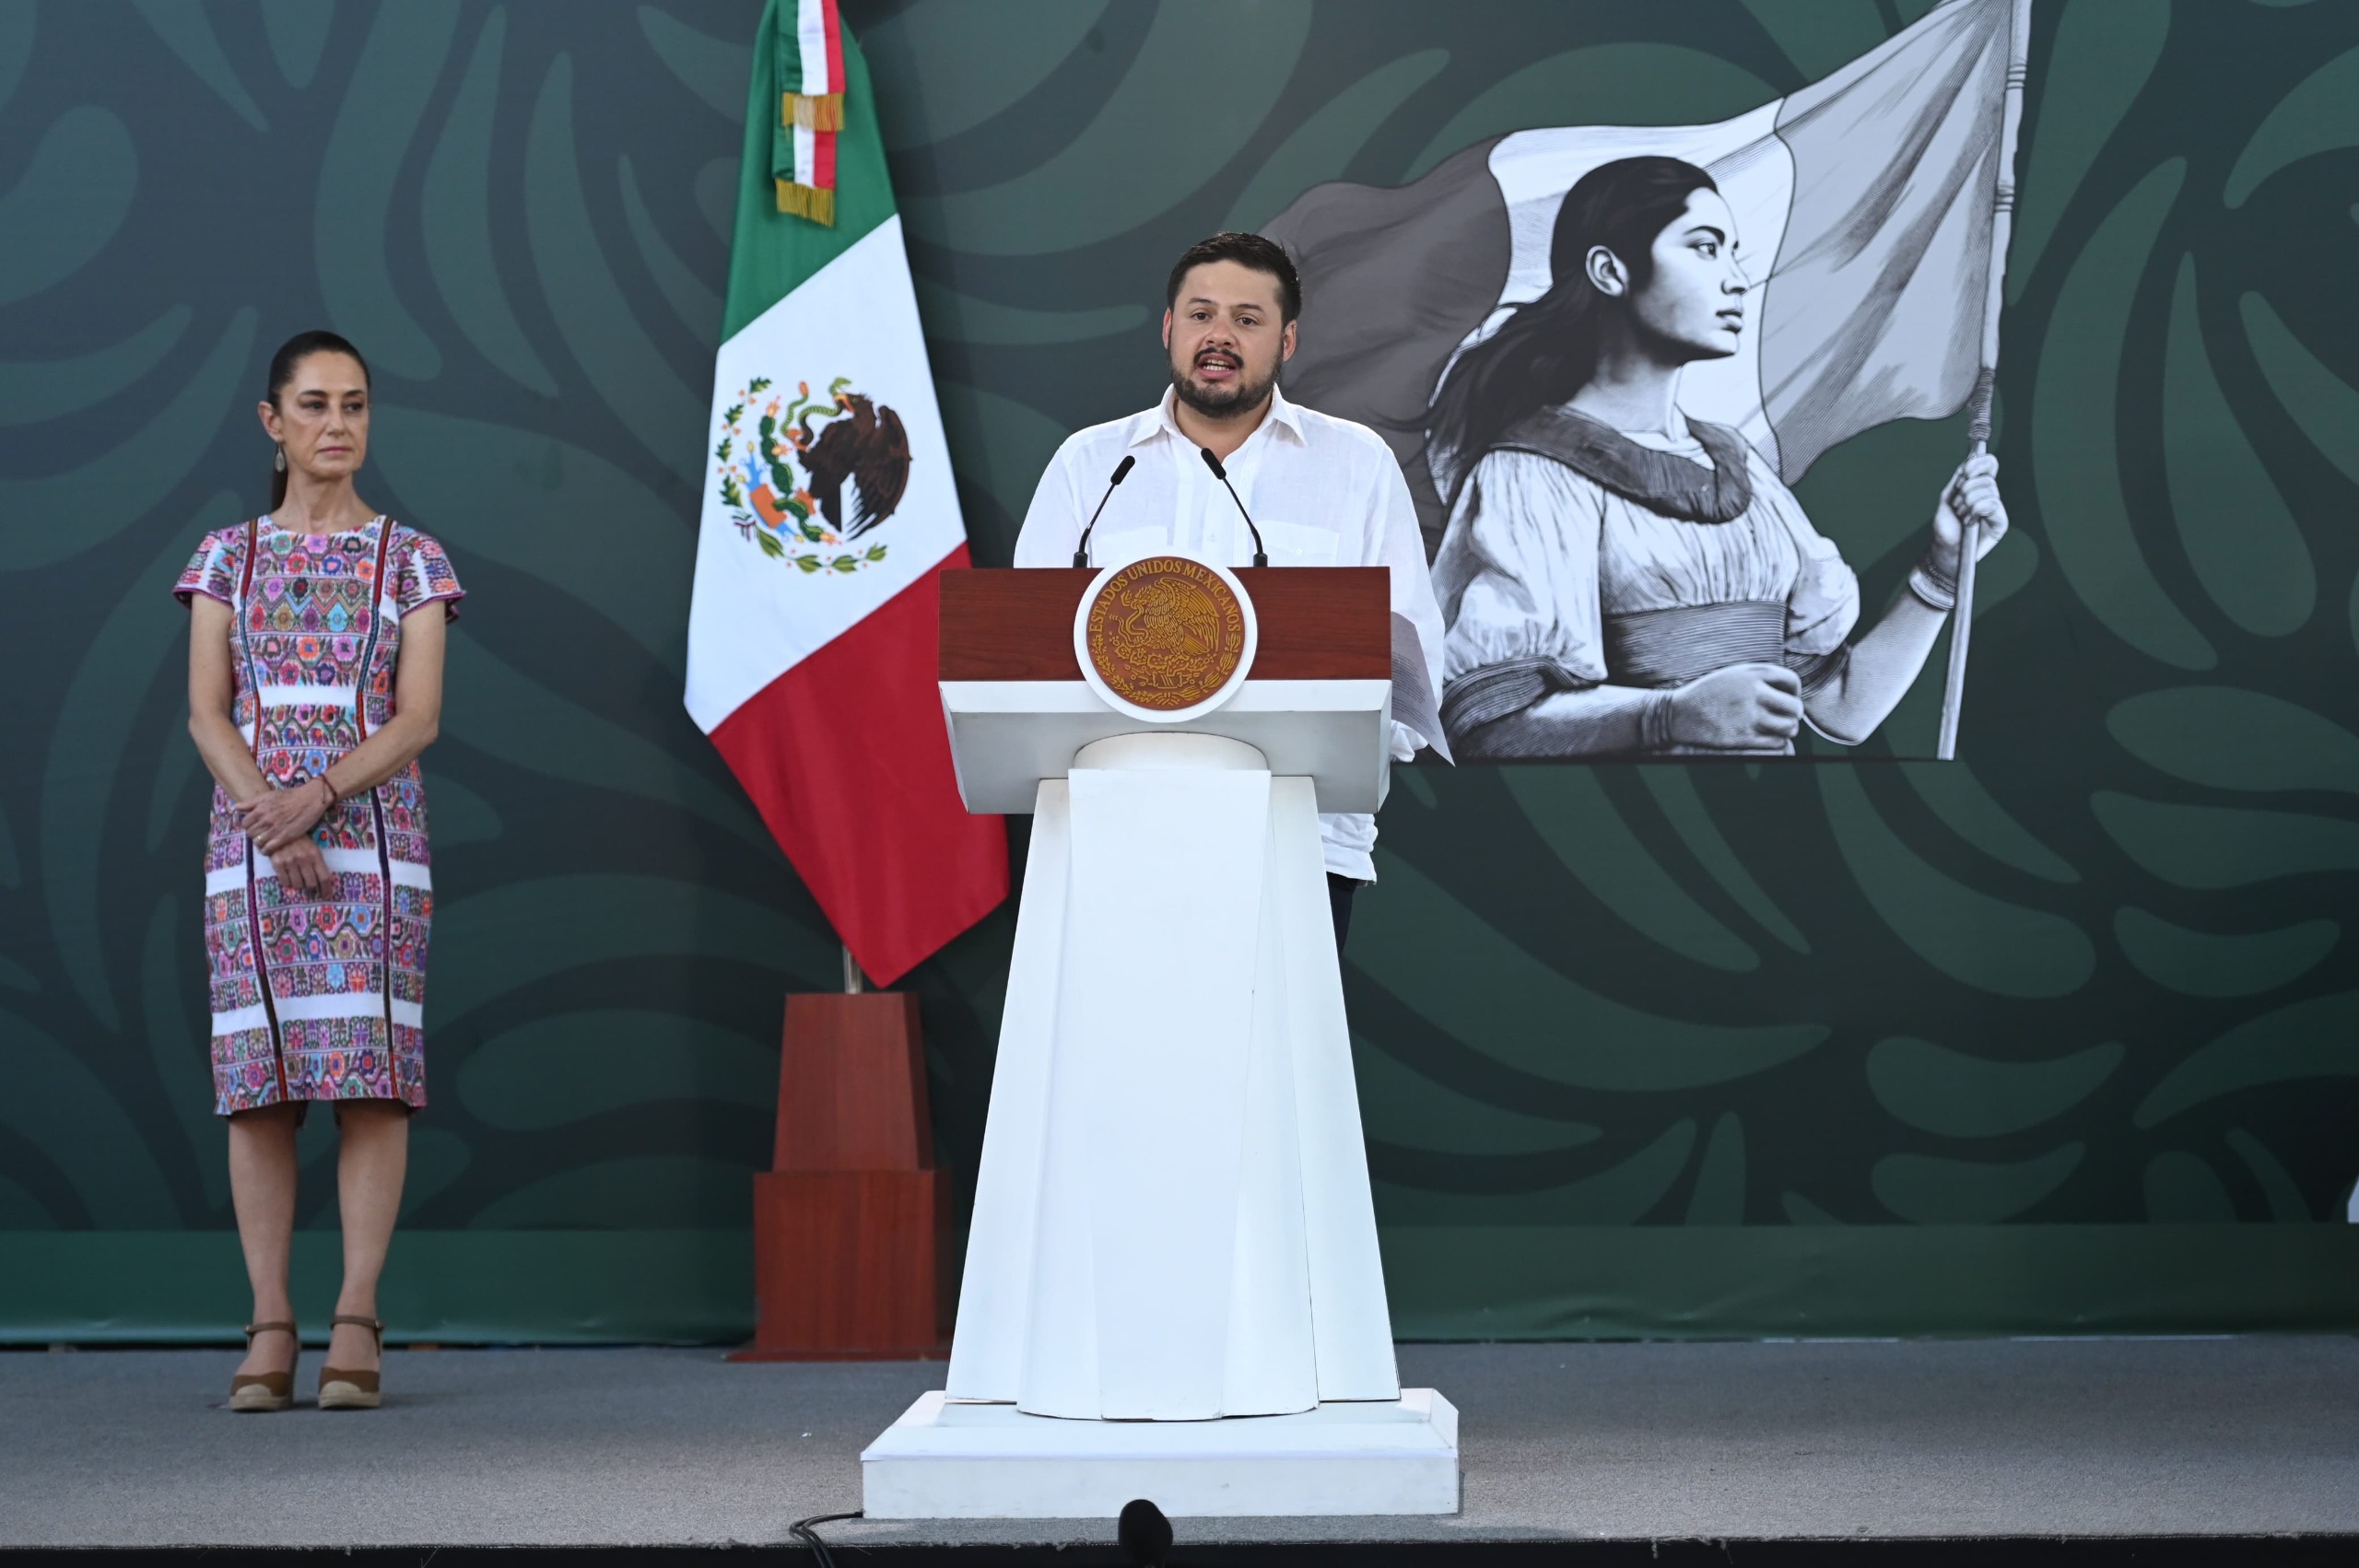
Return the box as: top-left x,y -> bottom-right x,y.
712,375 -> 909,575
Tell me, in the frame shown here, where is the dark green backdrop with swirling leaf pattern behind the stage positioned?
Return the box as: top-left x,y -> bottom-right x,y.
0,0 -> 2359,1340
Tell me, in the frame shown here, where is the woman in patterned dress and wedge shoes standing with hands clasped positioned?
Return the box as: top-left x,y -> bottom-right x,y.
174,333 -> 463,1410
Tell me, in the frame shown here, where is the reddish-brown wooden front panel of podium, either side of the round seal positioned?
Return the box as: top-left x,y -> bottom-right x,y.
939,566 -> 1391,682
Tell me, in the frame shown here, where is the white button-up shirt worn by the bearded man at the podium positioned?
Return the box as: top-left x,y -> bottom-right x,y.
1016,380 -> 1441,882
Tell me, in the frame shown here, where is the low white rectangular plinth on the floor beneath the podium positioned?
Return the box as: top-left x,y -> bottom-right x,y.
861,1388 -> 1458,1518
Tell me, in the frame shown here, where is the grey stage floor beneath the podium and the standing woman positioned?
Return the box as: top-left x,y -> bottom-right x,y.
0,1337 -> 2359,1551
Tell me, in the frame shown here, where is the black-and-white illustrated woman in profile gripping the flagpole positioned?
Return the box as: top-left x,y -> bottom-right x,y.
1429,158 -> 2008,762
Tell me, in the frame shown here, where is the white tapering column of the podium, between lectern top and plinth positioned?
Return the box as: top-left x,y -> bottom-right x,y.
944,733 -> 1402,1422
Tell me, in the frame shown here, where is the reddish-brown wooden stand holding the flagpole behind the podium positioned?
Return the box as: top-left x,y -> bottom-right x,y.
729,990 -> 948,1361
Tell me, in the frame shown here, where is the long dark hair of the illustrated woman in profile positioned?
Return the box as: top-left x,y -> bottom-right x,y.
1427,158 -> 1719,492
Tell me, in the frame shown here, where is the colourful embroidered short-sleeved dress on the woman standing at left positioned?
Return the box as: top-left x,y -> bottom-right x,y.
172,517 -> 464,1116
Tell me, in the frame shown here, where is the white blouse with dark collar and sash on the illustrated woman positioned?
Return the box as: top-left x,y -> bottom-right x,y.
1434,410 -> 1859,757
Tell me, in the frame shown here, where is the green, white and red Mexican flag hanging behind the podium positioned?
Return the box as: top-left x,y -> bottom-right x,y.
687,0 -> 1007,986
